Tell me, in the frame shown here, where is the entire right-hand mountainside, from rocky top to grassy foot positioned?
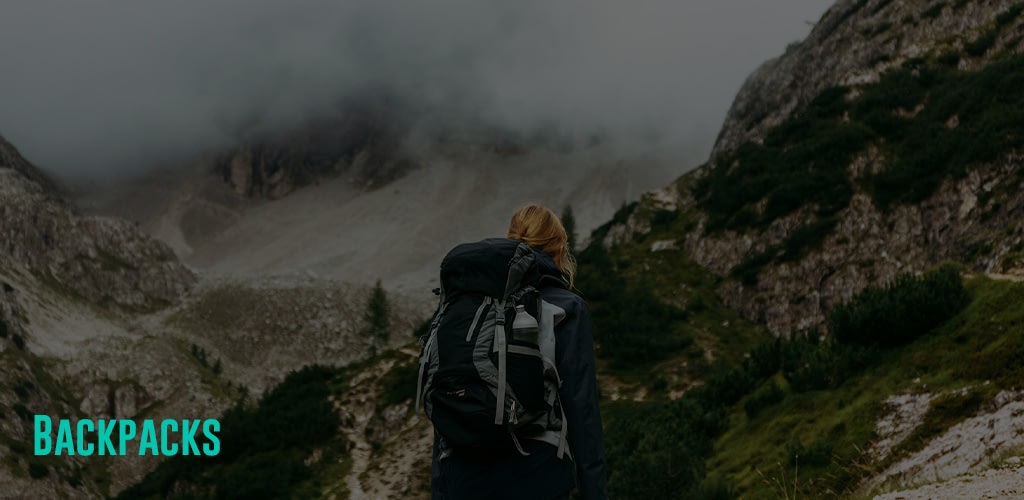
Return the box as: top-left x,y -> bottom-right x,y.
580,0 -> 1024,498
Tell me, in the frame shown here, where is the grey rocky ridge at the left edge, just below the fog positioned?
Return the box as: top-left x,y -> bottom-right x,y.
0,139 -> 196,309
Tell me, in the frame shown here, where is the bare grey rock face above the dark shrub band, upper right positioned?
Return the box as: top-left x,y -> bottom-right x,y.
712,0 -> 1021,159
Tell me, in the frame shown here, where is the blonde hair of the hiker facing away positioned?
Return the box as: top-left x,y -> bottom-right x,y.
508,204 -> 577,288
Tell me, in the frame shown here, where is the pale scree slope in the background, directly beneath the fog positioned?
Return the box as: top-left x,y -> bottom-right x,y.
78,130 -> 674,299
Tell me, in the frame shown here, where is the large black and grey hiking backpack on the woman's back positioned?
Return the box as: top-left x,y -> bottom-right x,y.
416,239 -> 565,458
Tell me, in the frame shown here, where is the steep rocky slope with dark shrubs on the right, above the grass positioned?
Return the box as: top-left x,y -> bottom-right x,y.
607,0 -> 1024,335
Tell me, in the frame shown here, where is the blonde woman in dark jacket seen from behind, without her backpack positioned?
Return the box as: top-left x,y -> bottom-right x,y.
431,205 -> 607,500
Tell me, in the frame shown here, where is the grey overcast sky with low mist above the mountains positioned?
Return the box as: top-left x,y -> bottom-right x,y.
0,0 -> 831,176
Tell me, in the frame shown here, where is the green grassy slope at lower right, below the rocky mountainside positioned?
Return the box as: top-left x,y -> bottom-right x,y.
708,277 -> 1024,498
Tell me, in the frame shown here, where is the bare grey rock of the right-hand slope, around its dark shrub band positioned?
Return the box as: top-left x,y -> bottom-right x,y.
604,0 -> 1024,335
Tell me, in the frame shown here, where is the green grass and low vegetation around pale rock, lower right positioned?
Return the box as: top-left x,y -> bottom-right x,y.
706,269 -> 1024,498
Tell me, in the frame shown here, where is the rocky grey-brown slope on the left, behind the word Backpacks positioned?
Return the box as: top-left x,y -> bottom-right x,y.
0,136 -> 425,498
